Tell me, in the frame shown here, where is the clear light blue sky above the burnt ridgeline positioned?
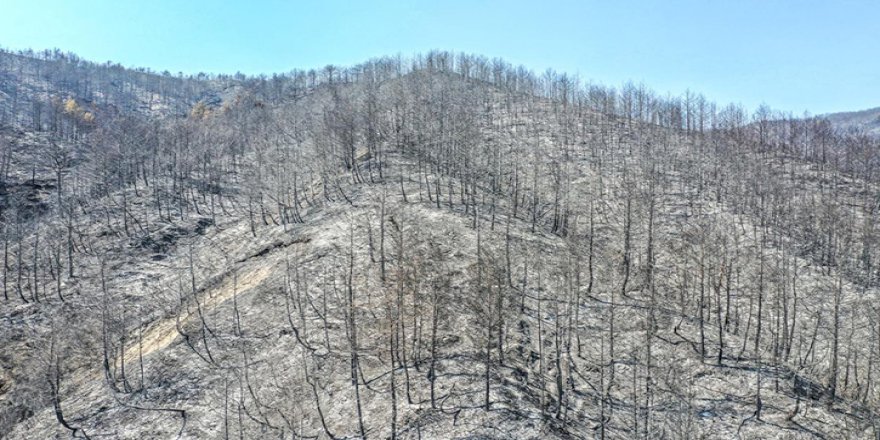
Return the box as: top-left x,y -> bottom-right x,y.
0,0 -> 880,114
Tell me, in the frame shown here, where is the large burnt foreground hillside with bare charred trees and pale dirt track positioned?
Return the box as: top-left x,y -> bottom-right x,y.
0,52 -> 880,439
